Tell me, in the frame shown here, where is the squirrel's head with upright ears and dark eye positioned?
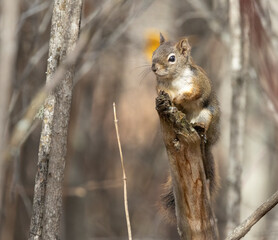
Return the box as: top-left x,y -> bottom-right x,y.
152,33 -> 191,80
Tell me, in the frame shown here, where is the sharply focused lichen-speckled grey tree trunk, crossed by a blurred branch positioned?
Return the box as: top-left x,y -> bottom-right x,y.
29,0 -> 82,239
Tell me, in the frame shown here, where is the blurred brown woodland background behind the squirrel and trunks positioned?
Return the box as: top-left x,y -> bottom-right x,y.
0,0 -> 278,240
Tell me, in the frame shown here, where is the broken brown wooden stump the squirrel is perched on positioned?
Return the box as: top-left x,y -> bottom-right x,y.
156,92 -> 218,240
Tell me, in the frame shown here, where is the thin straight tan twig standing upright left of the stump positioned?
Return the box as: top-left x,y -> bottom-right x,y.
113,103 -> 132,240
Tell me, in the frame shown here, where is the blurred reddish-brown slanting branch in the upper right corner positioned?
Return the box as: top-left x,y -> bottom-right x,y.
243,1 -> 278,127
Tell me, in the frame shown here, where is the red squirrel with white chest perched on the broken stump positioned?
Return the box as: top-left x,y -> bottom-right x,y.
151,34 -> 220,221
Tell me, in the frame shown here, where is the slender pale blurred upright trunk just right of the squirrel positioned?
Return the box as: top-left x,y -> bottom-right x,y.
226,0 -> 249,232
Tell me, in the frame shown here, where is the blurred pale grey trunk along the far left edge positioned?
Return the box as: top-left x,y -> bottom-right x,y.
0,0 -> 19,229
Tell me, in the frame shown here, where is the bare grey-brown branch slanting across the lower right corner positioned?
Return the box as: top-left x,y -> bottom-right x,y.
226,191 -> 278,240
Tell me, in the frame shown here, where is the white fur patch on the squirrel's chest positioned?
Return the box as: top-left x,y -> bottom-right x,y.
171,67 -> 194,95
